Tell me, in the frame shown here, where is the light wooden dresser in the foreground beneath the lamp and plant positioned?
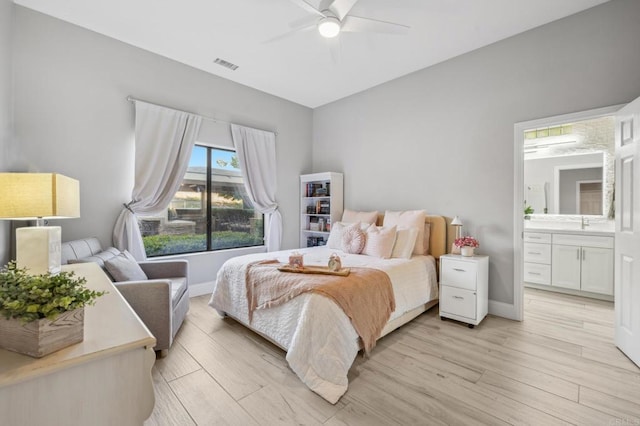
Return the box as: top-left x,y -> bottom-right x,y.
0,263 -> 155,425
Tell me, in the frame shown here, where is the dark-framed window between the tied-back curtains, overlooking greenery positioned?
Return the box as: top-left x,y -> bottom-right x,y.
138,145 -> 264,257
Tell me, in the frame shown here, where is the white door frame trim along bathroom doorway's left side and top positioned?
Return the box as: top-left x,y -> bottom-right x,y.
513,104 -> 626,321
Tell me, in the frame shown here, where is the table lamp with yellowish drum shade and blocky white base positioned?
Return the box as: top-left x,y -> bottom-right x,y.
0,173 -> 80,274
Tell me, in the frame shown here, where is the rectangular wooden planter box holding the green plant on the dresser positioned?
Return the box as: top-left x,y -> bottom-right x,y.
0,308 -> 84,358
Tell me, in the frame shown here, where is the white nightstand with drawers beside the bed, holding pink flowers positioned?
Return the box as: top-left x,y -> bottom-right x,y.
440,254 -> 489,328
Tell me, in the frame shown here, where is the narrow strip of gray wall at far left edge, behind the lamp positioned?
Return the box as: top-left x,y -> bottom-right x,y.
0,0 -> 13,265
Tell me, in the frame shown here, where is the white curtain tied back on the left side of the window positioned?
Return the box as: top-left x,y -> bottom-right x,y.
113,101 -> 202,260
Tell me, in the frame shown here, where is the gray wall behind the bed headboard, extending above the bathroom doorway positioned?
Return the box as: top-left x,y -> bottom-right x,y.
313,0 -> 640,304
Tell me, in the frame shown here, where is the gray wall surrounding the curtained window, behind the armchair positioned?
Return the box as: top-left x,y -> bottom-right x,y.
14,6 -> 312,282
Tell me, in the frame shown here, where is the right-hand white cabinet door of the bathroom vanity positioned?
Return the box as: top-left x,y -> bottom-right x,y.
581,247 -> 613,295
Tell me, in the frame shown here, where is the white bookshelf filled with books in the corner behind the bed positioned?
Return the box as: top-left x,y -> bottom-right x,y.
300,172 -> 343,247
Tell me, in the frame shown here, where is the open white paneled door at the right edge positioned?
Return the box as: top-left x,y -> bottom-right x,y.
614,98 -> 640,365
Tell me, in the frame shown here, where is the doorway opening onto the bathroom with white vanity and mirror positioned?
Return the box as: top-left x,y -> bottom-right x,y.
514,106 -> 620,319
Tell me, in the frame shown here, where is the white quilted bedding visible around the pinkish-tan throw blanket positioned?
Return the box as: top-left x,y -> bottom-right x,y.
209,247 -> 438,404
